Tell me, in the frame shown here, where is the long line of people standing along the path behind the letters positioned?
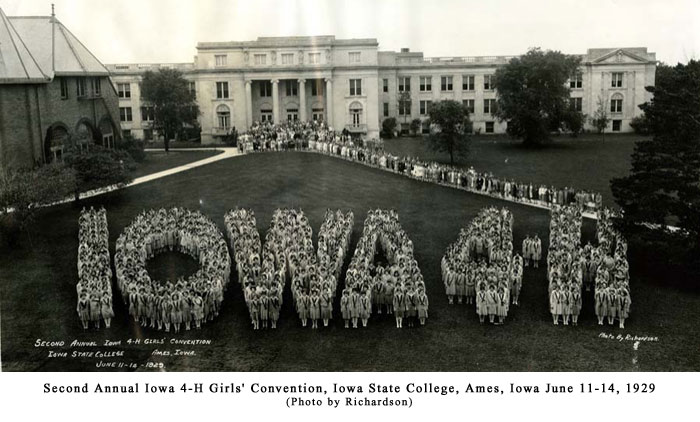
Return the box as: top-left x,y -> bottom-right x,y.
238,121 -> 603,213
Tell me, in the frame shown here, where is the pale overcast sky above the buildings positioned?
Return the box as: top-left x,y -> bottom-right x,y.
0,0 -> 700,64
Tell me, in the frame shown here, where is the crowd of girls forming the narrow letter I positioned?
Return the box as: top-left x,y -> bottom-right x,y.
76,207 -> 114,330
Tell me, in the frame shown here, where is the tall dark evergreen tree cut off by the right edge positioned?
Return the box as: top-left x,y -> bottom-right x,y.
611,60 -> 700,274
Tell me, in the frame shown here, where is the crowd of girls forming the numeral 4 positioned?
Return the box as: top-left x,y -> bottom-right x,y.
441,207 -> 523,324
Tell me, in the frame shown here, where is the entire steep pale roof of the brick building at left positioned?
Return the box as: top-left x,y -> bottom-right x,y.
0,10 -> 109,83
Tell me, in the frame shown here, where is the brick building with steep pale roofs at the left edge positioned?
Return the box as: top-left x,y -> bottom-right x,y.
0,9 -> 119,168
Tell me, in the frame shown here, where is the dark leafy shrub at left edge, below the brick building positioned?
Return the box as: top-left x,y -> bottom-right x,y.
0,164 -> 75,245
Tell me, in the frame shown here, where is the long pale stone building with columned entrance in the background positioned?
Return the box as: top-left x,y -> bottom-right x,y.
107,36 -> 656,143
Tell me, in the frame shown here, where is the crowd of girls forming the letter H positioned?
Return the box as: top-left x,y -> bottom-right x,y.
547,206 -> 632,328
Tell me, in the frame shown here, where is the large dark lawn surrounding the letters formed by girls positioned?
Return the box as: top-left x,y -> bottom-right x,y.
0,153 -> 700,371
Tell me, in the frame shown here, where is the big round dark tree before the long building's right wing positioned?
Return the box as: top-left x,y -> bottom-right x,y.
494,48 -> 583,145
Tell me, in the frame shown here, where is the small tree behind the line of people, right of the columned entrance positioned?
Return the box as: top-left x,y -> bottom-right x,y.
428,100 -> 471,165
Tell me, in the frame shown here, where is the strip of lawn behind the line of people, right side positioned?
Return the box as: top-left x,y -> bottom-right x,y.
384,134 -> 639,206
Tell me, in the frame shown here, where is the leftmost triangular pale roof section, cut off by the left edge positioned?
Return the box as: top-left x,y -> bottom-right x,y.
0,9 -> 50,84
